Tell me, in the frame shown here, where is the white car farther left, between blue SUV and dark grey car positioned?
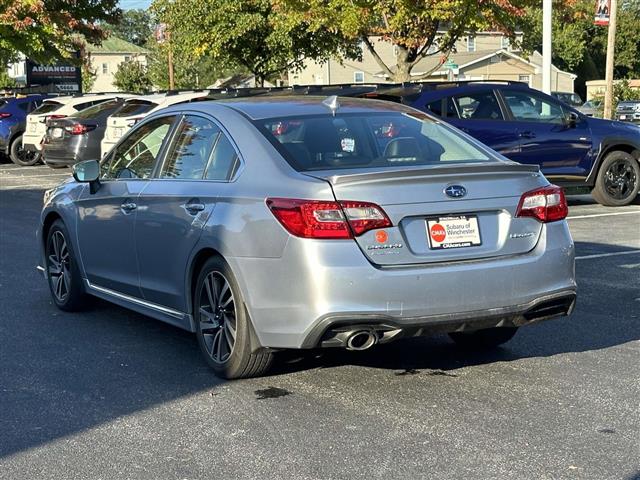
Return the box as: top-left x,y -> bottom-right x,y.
22,93 -> 131,158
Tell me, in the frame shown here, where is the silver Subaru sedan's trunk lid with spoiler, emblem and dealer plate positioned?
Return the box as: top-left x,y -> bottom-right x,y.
306,162 -> 546,266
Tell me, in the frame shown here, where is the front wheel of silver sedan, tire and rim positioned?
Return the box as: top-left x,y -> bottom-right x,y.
45,219 -> 88,312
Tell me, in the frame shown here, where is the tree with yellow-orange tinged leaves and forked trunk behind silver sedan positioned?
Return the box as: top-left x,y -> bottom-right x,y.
275,0 -> 536,82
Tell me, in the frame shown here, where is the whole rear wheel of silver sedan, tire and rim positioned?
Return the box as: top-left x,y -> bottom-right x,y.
193,256 -> 273,379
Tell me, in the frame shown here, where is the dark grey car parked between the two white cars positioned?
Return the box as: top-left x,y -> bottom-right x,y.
42,98 -> 130,168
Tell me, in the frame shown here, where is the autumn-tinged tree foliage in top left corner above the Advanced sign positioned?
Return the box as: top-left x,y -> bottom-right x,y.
0,0 -> 121,63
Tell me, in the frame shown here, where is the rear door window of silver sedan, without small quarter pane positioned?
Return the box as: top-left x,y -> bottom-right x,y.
160,115 -> 220,179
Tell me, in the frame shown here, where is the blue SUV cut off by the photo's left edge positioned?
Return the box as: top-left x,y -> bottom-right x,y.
0,95 -> 47,165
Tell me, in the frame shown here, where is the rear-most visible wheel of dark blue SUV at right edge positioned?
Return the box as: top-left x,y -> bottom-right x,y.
591,151 -> 640,207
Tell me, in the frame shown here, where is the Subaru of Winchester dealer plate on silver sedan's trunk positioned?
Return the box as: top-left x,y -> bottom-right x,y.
427,215 -> 482,250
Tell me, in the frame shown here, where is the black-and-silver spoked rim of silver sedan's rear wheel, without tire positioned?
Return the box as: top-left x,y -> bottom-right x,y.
198,272 -> 237,364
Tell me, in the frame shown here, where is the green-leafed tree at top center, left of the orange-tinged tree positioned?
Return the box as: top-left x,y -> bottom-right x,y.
152,0 -> 357,85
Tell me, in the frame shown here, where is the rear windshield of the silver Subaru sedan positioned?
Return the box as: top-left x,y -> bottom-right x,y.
256,113 -> 497,171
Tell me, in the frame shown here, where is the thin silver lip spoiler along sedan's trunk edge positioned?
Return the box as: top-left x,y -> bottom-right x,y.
301,162 -> 540,185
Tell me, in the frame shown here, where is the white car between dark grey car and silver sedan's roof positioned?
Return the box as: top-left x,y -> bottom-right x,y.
100,90 -> 209,157
